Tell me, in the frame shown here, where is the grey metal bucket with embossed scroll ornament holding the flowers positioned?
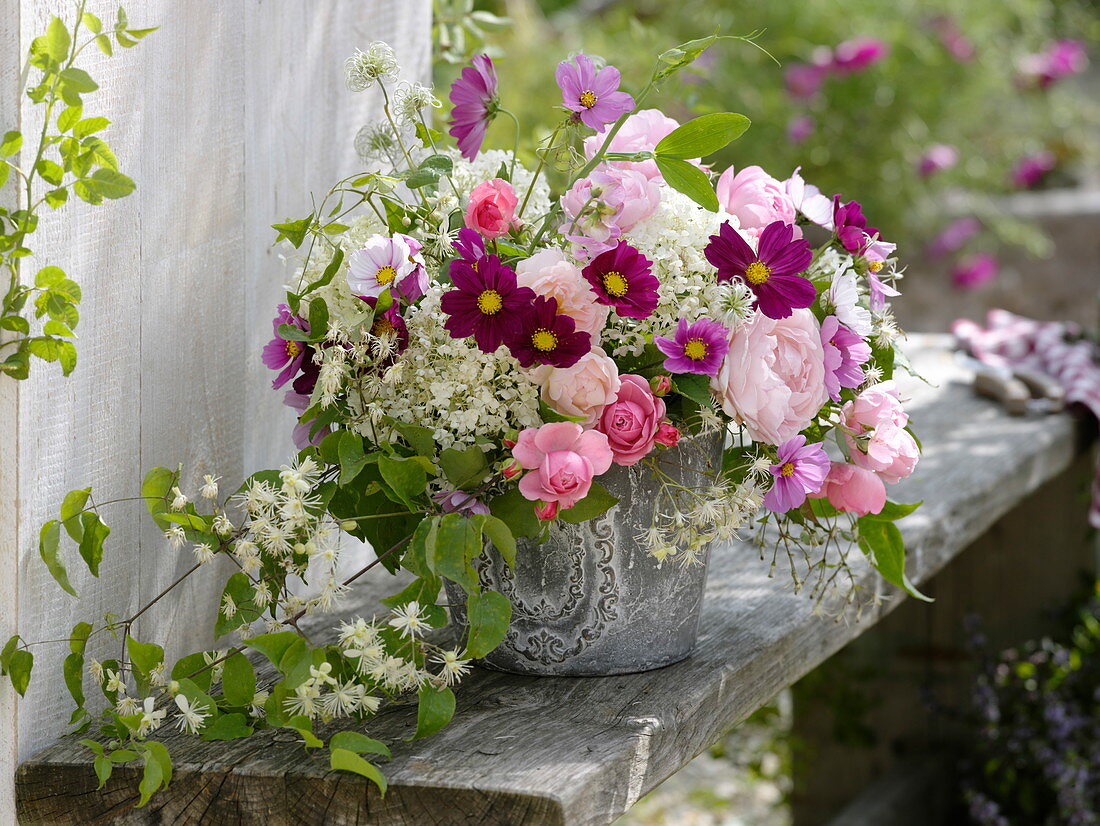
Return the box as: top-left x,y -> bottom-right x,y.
447,436 -> 722,676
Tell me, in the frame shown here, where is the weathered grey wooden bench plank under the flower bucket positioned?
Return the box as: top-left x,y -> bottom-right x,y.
17,337 -> 1091,826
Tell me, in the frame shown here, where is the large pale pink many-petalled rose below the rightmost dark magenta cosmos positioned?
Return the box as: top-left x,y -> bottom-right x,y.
711,310 -> 828,444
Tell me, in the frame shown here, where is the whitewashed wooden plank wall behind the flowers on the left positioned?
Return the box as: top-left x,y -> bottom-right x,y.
0,0 -> 431,823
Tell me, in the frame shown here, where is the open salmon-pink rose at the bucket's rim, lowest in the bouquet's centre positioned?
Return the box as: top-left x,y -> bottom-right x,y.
512,421 -> 612,510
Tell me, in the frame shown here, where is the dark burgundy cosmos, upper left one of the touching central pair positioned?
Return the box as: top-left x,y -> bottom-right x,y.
439,255 -> 535,353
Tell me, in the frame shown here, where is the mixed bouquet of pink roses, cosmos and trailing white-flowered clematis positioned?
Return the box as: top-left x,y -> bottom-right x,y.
0,36 -> 919,799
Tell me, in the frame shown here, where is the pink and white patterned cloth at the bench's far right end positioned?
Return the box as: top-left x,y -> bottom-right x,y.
952,310 -> 1100,529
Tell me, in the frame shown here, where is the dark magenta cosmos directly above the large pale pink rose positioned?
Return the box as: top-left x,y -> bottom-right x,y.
704,221 -> 817,318
